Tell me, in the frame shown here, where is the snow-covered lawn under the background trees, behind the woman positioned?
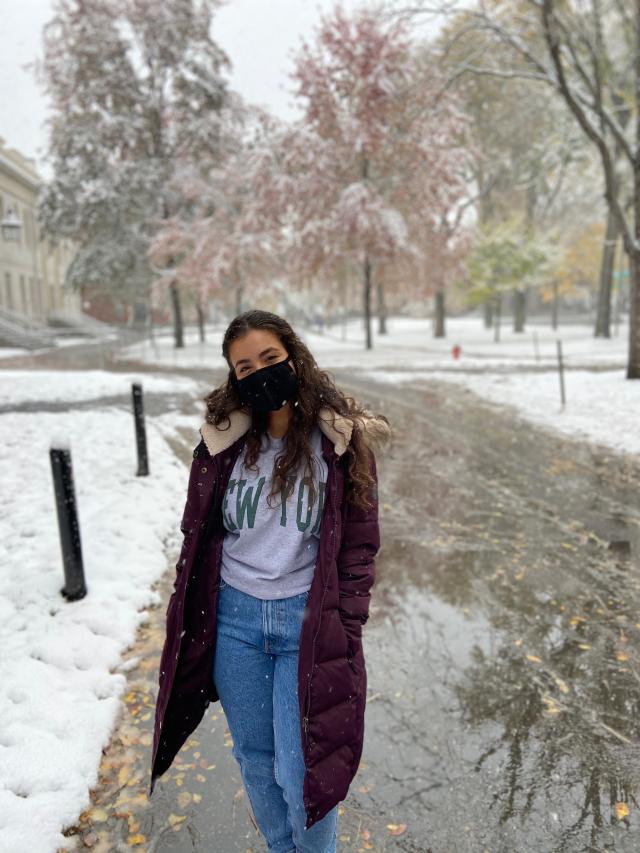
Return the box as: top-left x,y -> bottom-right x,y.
117,317 -> 640,462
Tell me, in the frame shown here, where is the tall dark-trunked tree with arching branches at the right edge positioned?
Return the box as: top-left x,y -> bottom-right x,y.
404,0 -> 640,379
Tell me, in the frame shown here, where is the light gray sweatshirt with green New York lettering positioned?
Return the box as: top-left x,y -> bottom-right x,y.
220,425 -> 327,599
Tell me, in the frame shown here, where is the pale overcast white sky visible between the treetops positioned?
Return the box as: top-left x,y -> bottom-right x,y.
0,0 -> 440,179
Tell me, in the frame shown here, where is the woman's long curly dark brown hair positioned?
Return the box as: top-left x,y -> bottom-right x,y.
203,309 -> 390,509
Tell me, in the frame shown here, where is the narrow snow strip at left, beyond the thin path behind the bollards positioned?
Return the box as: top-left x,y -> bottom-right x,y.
0,370 -> 202,406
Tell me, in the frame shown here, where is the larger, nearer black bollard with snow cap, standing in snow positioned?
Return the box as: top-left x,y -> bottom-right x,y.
49,447 -> 87,601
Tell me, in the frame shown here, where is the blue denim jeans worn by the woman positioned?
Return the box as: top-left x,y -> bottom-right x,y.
213,580 -> 338,853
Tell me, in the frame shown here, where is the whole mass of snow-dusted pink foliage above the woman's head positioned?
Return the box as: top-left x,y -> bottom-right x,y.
149,4 -> 468,308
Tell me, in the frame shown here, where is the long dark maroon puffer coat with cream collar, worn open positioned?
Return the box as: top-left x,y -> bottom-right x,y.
149,407 -> 388,828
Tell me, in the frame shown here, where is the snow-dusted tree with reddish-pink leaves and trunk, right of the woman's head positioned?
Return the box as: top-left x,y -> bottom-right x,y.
282,4 -> 466,348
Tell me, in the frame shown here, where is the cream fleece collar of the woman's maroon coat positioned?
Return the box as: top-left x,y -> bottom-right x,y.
200,406 -> 391,456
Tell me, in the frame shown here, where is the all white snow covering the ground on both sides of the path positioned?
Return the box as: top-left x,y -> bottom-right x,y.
0,318 -> 640,853
